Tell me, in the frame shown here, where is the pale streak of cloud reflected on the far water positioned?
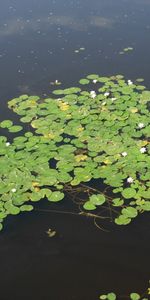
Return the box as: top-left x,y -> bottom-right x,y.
0,15 -> 114,38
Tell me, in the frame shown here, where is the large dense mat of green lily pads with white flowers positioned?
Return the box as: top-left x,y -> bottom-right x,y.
0,74 -> 150,228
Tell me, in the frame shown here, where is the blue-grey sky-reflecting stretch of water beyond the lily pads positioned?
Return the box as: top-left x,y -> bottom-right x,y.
0,0 -> 150,105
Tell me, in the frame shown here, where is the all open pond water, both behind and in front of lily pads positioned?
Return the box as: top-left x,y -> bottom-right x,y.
0,0 -> 150,300
